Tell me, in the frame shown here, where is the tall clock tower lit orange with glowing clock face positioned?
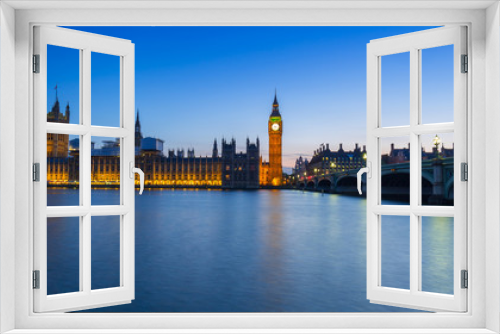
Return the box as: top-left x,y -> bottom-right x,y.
267,93 -> 283,186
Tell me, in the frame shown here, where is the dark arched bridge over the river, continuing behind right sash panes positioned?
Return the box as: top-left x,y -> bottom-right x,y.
291,157 -> 454,204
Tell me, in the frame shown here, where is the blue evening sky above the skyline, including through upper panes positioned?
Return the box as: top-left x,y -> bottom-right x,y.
48,27 -> 453,167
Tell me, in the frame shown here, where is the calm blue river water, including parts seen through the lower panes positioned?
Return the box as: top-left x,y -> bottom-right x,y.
47,189 -> 453,312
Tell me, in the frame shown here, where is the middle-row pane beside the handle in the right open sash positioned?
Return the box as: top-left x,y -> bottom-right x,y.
380,136 -> 410,205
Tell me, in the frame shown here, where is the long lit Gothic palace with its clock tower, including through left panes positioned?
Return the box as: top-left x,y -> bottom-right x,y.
47,94 -> 283,189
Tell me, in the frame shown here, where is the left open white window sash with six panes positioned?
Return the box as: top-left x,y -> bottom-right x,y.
33,26 -> 135,312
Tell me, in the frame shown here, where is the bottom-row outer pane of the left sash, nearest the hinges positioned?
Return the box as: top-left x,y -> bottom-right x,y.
47,217 -> 80,295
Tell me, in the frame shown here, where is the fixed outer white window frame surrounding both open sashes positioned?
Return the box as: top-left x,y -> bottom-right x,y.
0,0 -> 500,333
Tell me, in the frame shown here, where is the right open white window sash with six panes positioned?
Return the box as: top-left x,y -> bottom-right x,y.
367,26 -> 467,312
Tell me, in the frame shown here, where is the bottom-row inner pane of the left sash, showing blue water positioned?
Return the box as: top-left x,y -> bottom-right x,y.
91,216 -> 121,290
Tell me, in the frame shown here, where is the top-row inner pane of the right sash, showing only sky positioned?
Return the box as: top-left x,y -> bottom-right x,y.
380,52 -> 410,127
